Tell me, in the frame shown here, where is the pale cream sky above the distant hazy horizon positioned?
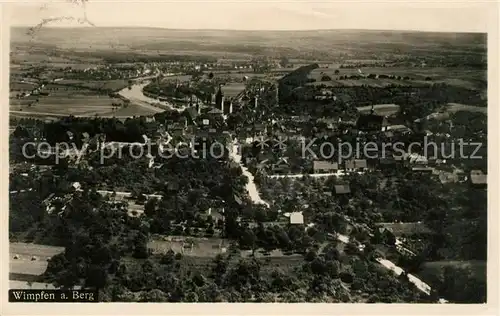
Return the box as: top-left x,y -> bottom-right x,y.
8,0 -> 495,32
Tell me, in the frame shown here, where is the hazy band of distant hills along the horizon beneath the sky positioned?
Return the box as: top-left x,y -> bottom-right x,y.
11,27 -> 486,60
